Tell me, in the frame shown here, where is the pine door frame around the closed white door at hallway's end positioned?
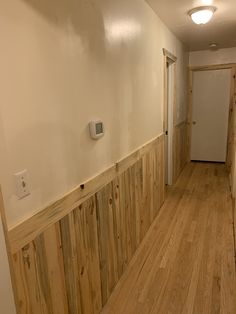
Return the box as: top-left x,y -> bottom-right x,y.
187,63 -> 236,171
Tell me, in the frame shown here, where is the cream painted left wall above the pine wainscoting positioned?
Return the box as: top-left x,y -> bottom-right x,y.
0,0 -> 188,226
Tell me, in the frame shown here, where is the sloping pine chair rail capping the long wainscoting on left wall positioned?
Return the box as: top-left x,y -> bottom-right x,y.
8,134 -> 164,253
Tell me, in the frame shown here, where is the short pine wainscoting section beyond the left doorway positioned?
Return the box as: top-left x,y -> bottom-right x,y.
173,121 -> 188,182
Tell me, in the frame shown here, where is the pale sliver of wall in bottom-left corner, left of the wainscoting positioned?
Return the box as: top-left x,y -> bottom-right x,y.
0,217 -> 16,314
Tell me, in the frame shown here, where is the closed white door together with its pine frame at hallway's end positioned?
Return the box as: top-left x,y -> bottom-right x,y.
188,64 -> 235,170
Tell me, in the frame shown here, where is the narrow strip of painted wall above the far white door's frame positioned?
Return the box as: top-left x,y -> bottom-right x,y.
189,47 -> 236,66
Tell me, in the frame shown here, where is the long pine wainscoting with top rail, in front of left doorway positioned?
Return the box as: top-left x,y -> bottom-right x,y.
3,131 -> 166,314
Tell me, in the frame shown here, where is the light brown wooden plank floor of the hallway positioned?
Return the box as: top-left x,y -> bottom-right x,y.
102,163 -> 236,314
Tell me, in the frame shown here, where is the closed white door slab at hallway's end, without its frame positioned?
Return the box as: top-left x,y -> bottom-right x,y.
191,69 -> 231,162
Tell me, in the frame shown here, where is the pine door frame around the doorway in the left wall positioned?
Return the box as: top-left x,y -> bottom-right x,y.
163,48 -> 177,185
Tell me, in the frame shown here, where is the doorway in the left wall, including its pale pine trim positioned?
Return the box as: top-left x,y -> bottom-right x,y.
163,49 -> 177,186
